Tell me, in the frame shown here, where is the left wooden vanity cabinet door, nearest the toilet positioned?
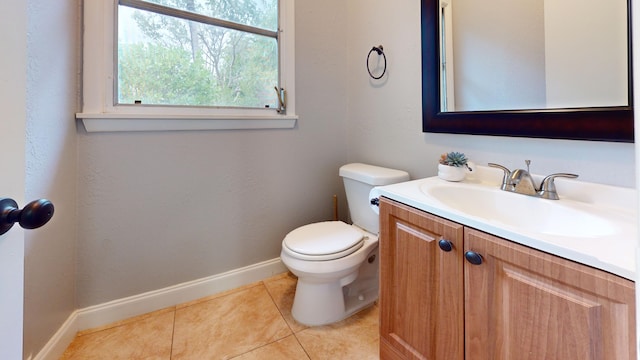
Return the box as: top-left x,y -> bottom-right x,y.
380,198 -> 464,360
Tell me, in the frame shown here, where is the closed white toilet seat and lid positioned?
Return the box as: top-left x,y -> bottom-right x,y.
282,221 -> 364,261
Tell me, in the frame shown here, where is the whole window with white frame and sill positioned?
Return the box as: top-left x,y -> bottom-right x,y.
76,0 -> 297,131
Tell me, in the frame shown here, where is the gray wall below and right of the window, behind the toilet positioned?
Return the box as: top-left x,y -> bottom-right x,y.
77,0 -> 347,308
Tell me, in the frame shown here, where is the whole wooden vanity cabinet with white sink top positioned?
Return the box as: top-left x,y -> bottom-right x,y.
375,169 -> 636,360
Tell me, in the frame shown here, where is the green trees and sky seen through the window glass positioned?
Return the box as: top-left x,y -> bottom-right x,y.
114,0 -> 280,108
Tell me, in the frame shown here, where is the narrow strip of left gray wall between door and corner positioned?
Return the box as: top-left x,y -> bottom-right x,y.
23,0 -> 80,357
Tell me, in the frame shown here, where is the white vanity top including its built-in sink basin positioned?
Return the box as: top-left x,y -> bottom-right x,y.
371,166 -> 638,281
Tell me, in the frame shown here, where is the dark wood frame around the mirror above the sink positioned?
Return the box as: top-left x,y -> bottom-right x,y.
422,0 -> 634,142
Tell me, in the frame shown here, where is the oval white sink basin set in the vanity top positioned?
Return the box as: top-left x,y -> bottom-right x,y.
420,184 -> 616,238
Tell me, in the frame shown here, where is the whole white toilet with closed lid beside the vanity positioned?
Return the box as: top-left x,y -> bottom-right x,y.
280,163 -> 409,325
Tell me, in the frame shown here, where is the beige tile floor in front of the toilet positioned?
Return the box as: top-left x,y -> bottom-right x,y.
61,274 -> 379,360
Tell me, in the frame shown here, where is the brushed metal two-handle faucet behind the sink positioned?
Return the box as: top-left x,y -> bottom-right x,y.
489,160 -> 578,200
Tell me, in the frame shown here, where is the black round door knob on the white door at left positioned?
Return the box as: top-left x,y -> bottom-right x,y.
0,198 -> 53,235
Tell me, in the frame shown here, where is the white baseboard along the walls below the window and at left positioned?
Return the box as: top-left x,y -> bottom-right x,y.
33,258 -> 287,360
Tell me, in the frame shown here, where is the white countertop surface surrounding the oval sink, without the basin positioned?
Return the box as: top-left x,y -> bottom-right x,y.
371,166 -> 638,281
